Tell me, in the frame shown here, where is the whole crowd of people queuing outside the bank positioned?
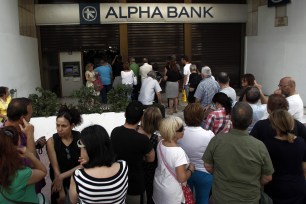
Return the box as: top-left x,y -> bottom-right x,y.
0,56 -> 306,204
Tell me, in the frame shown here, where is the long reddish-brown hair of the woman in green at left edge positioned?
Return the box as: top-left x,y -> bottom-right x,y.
0,126 -> 23,191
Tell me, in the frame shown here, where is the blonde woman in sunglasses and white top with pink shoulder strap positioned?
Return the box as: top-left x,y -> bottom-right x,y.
153,116 -> 195,204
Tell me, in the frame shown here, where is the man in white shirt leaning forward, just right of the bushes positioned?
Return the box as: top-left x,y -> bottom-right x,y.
138,71 -> 165,117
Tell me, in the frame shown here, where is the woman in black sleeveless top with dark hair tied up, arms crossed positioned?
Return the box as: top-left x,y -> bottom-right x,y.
47,106 -> 82,204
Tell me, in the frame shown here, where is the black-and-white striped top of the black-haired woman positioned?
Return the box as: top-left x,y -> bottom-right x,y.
73,160 -> 128,204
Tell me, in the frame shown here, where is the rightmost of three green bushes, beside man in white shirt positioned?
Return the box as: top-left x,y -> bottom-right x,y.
107,85 -> 133,112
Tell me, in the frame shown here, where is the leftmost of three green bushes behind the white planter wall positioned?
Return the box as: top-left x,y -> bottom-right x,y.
29,87 -> 60,117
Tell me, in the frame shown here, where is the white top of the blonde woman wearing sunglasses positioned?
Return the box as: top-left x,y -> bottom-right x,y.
153,144 -> 189,204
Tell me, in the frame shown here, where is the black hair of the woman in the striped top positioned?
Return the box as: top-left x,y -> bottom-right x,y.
80,125 -> 115,168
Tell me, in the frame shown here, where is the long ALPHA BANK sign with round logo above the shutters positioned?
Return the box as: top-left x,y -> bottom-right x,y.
35,3 -> 247,25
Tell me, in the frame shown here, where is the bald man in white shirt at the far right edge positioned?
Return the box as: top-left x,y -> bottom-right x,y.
274,76 -> 304,122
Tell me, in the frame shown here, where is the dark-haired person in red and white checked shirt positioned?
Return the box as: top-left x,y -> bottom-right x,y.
204,92 -> 232,135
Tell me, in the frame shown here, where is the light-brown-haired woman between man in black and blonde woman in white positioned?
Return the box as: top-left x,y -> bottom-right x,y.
138,106 -> 163,204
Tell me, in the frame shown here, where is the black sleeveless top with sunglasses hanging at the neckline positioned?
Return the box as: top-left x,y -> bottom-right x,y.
50,130 -> 80,188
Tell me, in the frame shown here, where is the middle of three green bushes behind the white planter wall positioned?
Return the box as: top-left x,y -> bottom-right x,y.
72,86 -> 103,114
